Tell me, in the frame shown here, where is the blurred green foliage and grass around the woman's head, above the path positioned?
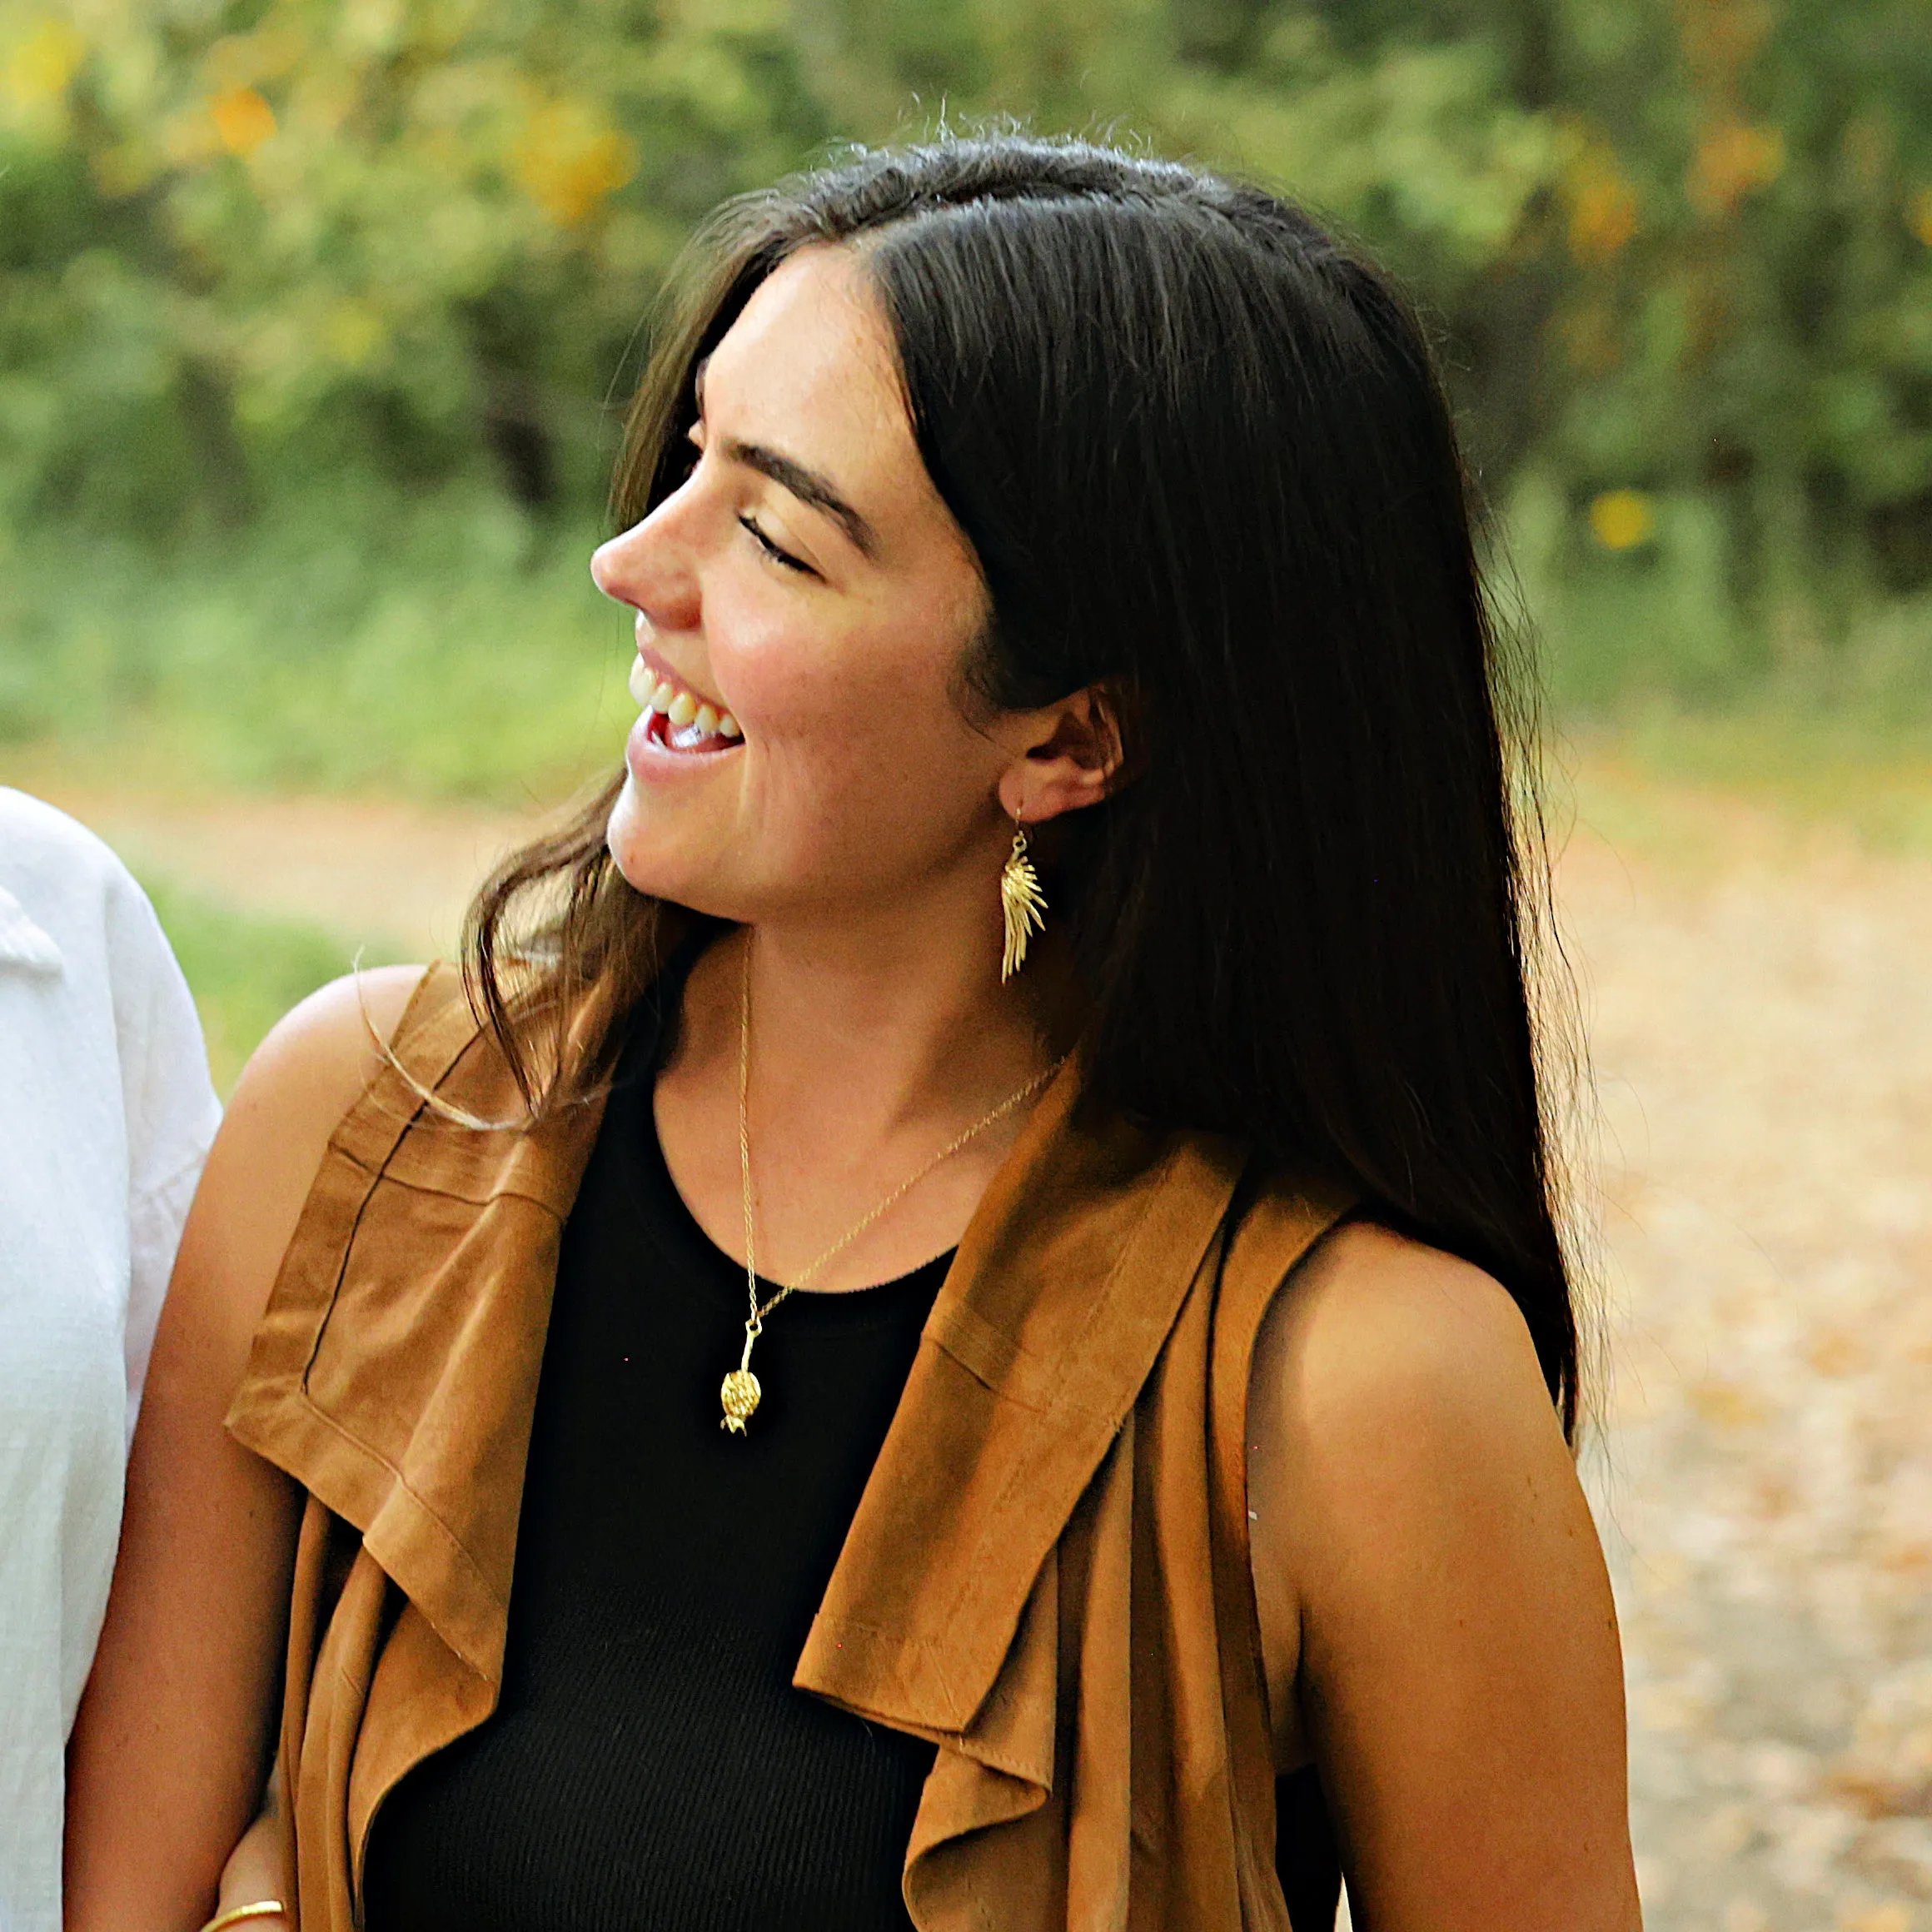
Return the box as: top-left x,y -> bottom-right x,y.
0,0 -> 1932,776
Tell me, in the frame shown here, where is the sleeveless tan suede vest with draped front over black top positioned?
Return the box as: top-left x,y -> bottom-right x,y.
228,968 -> 1347,1932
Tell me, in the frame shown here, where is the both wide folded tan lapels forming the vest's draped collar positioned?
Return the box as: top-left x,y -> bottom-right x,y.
228,968 -> 1240,1733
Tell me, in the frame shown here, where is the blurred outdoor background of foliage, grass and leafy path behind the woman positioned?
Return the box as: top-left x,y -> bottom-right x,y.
0,0 -> 1932,1932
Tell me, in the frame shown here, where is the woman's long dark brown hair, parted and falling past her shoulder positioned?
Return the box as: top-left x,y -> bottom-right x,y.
466,135 -> 1576,1427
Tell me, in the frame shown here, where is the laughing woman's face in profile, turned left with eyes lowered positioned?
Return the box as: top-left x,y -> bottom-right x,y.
591,247 -> 1026,919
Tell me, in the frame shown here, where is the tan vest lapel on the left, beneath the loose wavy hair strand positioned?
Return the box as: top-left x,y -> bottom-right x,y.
228,968 -> 601,1685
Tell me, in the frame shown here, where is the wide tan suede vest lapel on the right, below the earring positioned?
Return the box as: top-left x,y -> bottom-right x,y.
794,1063 -> 1240,1754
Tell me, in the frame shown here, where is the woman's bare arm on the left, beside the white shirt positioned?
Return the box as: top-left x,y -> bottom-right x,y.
66,966 -> 419,1932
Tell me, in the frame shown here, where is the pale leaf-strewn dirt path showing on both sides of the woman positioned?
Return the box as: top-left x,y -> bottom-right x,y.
15,771 -> 1932,1932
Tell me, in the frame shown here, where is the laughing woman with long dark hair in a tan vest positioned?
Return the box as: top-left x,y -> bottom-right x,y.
70,139 -> 1638,1932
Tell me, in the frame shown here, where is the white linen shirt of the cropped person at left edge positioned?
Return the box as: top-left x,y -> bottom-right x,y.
0,786 -> 220,1932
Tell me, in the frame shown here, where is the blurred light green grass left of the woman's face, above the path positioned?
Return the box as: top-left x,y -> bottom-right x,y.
0,489 -> 630,802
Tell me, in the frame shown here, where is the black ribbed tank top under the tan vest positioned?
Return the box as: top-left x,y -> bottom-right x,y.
363,976 -> 950,1932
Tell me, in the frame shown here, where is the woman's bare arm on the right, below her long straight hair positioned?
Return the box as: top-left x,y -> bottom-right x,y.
1248,1227 -> 1641,1932
